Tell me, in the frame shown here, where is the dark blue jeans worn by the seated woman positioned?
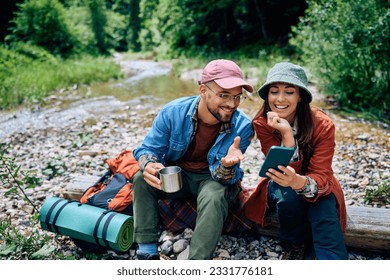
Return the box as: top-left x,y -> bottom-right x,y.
268,180 -> 348,260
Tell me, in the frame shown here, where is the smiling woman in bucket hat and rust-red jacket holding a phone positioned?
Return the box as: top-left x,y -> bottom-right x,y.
245,62 -> 348,259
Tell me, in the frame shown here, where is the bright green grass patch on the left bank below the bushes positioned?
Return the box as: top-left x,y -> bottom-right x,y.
0,43 -> 122,110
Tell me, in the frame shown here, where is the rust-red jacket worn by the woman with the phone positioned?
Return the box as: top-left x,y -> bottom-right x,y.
244,110 -> 347,232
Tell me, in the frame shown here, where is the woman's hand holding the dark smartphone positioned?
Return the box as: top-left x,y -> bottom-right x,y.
265,165 -> 306,190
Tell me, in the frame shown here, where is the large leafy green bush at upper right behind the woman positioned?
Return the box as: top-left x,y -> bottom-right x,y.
290,0 -> 390,117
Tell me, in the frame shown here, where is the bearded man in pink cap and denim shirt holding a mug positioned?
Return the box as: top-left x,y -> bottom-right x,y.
133,59 -> 253,260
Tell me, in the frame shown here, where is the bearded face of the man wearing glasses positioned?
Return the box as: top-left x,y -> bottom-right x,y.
201,82 -> 243,123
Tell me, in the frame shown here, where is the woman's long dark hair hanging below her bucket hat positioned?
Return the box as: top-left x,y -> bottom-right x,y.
253,87 -> 314,174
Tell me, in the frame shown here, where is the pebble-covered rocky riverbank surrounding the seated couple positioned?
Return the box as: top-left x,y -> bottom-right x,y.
0,57 -> 390,260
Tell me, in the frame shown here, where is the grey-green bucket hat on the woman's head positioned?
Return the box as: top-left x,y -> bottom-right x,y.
258,62 -> 313,103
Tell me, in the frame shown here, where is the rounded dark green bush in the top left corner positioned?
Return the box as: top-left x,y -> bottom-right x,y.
7,0 -> 77,56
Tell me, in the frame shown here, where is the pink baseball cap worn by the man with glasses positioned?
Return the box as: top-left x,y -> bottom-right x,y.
199,59 -> 253,92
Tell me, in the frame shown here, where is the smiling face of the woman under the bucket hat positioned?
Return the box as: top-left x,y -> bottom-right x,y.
268,83 -> 301,124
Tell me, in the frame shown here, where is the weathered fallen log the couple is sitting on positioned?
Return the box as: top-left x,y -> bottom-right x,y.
62,175 -> 390,254
